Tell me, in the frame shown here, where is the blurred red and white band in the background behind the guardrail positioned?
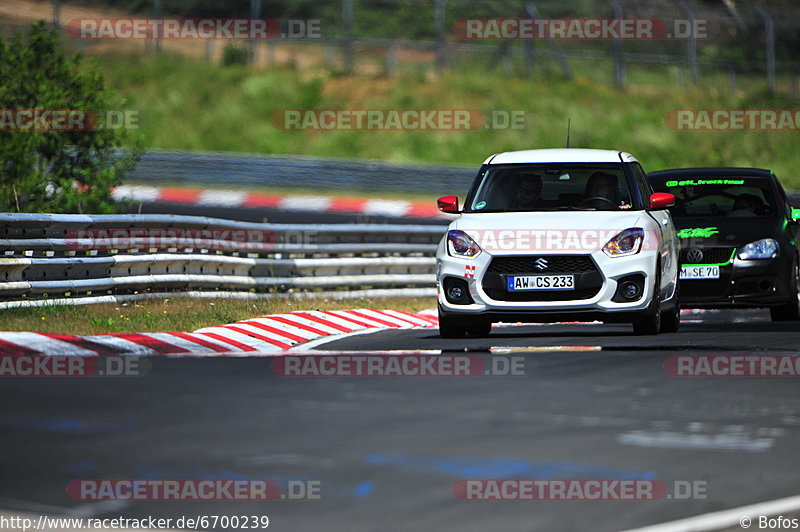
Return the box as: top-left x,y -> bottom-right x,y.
113,185 -> 447,218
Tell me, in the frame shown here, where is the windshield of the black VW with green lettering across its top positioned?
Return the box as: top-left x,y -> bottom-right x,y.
651,176 -> 776,218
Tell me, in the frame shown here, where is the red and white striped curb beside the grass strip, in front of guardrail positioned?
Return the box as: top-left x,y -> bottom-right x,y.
0,309 -> 439,356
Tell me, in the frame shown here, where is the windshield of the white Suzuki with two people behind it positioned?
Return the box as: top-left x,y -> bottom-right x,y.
467,164 -> 632,212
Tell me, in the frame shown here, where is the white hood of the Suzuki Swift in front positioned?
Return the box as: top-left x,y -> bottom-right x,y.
450,211 -> 648,255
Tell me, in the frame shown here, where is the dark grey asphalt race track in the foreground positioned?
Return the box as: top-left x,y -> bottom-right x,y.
0,311 -> 800,531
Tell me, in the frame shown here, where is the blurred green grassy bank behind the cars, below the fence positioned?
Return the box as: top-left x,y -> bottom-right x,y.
90,48 -> 800,189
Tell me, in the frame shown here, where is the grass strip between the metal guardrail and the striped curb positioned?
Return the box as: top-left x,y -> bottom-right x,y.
0,298 -> 436,335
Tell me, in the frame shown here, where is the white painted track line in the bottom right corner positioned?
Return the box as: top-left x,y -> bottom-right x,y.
625,495 -> 800,532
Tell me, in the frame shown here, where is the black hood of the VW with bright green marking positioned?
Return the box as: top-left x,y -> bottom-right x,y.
673,217 -> 783,248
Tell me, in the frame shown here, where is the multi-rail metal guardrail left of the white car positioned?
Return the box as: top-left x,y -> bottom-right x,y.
0,214 -> 444,308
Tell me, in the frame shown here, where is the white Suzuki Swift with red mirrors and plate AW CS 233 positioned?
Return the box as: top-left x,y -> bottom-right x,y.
436,149 -> 680,338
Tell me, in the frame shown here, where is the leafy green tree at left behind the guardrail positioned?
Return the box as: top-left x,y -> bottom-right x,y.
0,22 -> 143,213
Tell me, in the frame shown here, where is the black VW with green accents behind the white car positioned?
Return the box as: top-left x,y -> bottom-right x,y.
647,168 -> 800,321
